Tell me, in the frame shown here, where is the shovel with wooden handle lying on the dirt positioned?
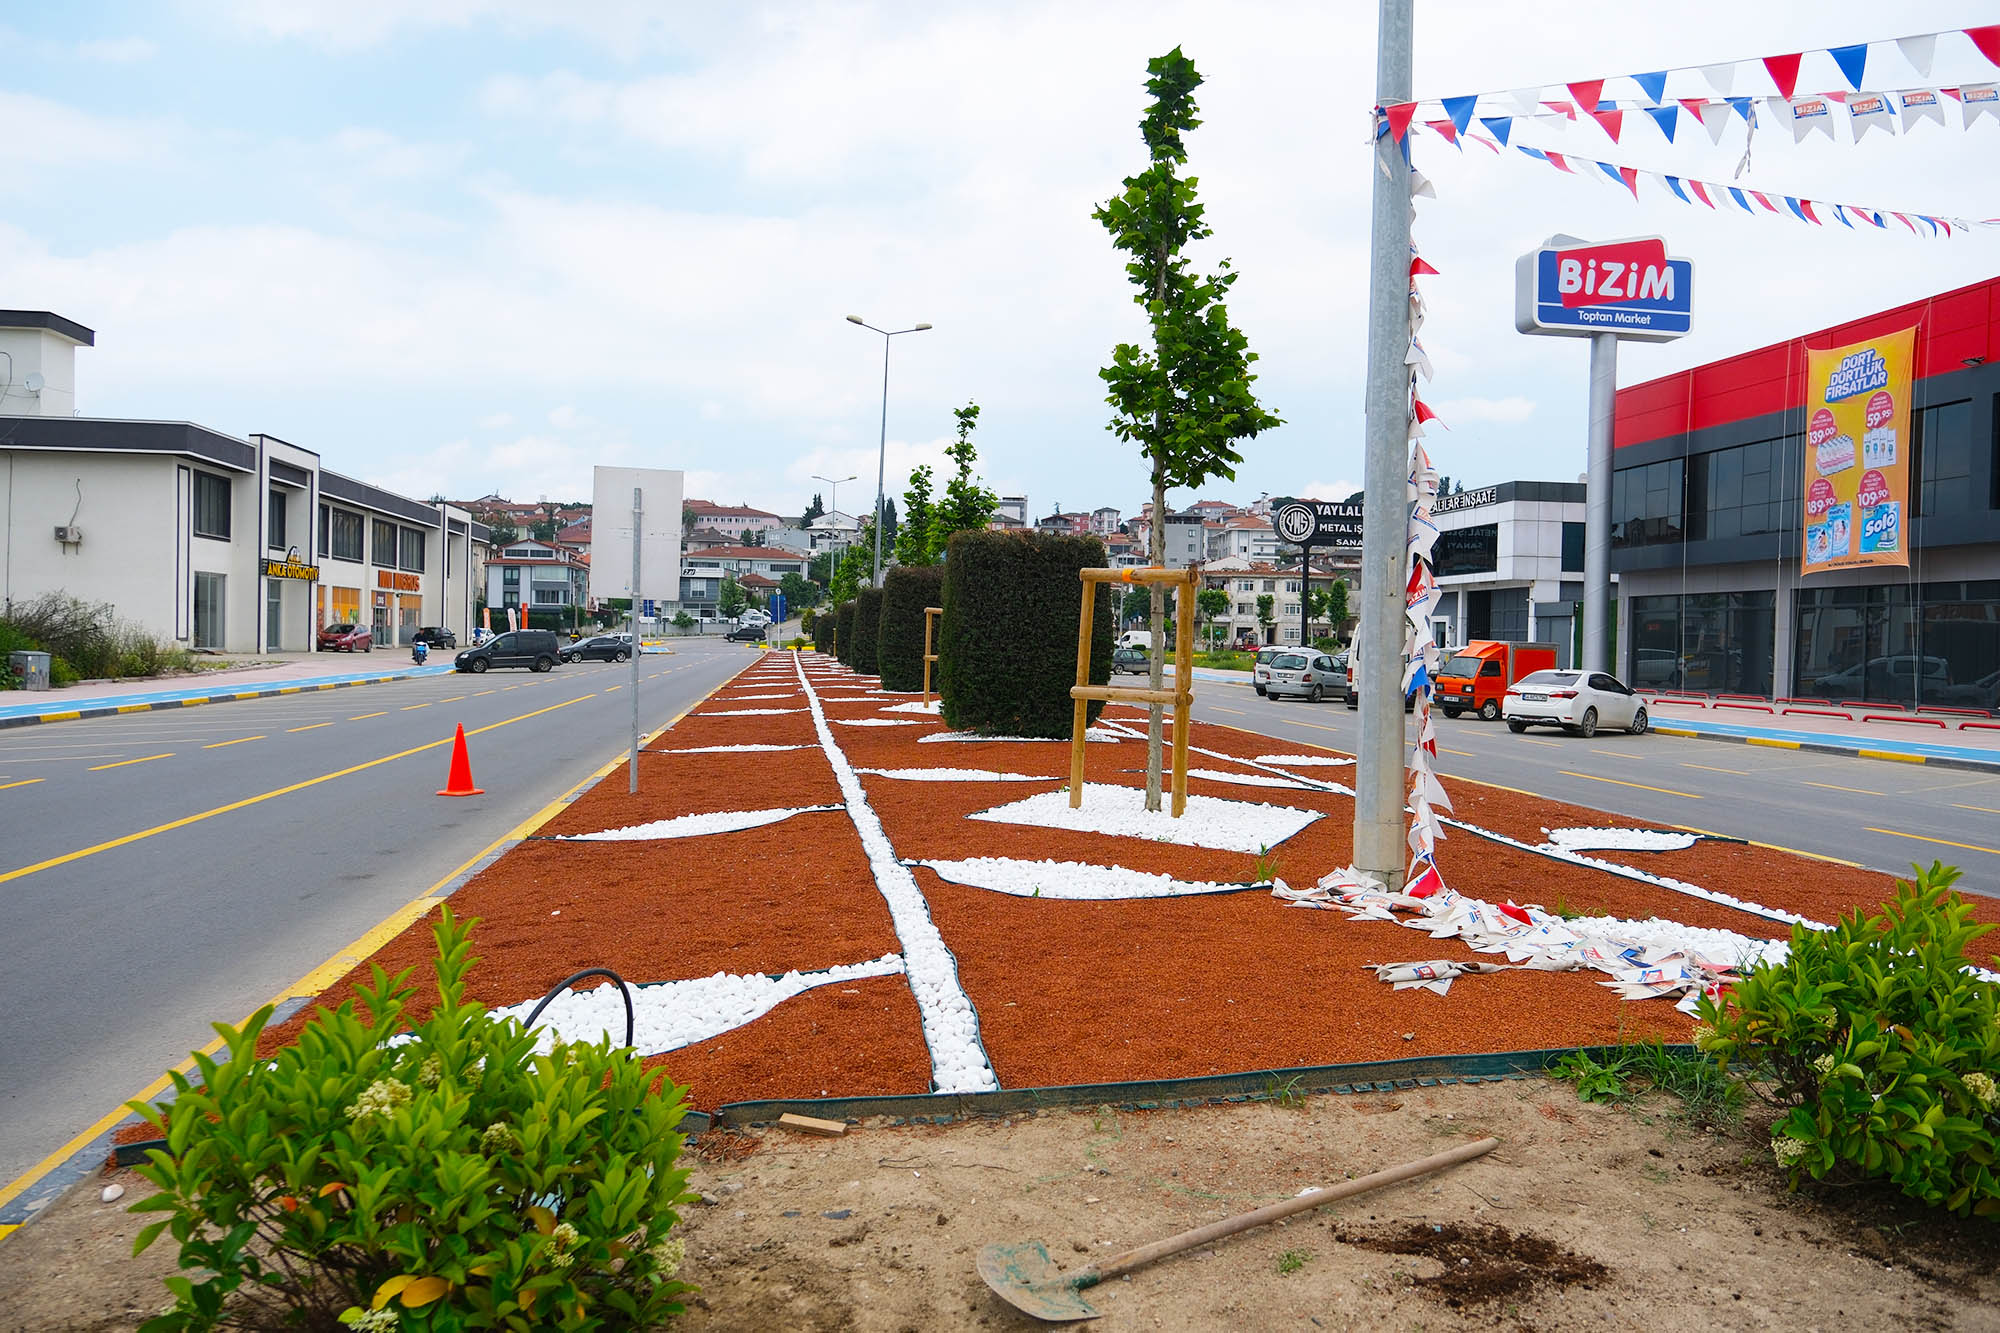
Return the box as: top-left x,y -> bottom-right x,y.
978,1139 -> 1500,1323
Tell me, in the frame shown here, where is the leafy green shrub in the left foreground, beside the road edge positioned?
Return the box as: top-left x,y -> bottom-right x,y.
130,909 -> 688,1333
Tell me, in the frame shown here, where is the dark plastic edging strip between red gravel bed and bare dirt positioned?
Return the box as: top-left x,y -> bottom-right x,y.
714,1045 -> 1694,1127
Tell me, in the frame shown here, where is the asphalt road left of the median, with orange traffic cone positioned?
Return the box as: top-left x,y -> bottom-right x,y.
0,638 -> 756,1187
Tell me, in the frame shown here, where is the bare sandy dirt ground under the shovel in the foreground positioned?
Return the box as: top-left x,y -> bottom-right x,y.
0,1081 -> 2000,1333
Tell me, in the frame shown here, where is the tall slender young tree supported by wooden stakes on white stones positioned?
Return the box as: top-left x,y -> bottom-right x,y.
1092,46 -> 1282,811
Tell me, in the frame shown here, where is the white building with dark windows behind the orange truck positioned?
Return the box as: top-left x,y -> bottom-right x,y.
1432,480 -> 1584,664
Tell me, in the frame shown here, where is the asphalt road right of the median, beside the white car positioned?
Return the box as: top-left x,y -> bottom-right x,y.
1194,681 -> 2000,895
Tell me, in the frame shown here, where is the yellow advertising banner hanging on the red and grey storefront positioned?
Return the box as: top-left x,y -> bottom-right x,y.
1798,328 -> 1916,574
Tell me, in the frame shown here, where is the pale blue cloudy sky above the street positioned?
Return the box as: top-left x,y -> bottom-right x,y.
0,0 -> 2000,516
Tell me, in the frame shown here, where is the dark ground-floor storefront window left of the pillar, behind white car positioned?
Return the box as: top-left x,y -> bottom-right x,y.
1626,592 -> 1778,697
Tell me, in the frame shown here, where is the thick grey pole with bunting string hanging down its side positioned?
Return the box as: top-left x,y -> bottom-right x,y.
1354,0 -> 1412,889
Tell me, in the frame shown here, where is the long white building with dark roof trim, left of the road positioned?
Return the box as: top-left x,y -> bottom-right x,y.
0,310 -> 488,652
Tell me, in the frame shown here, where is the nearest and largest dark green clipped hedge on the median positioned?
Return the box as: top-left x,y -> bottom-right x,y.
936,530 -> 1118,739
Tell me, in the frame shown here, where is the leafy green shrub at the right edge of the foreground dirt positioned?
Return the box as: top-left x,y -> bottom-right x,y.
1696,863 -> 2000,1217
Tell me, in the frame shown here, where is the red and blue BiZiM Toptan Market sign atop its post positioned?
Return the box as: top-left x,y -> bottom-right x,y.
1514,236 -> 1694,342
